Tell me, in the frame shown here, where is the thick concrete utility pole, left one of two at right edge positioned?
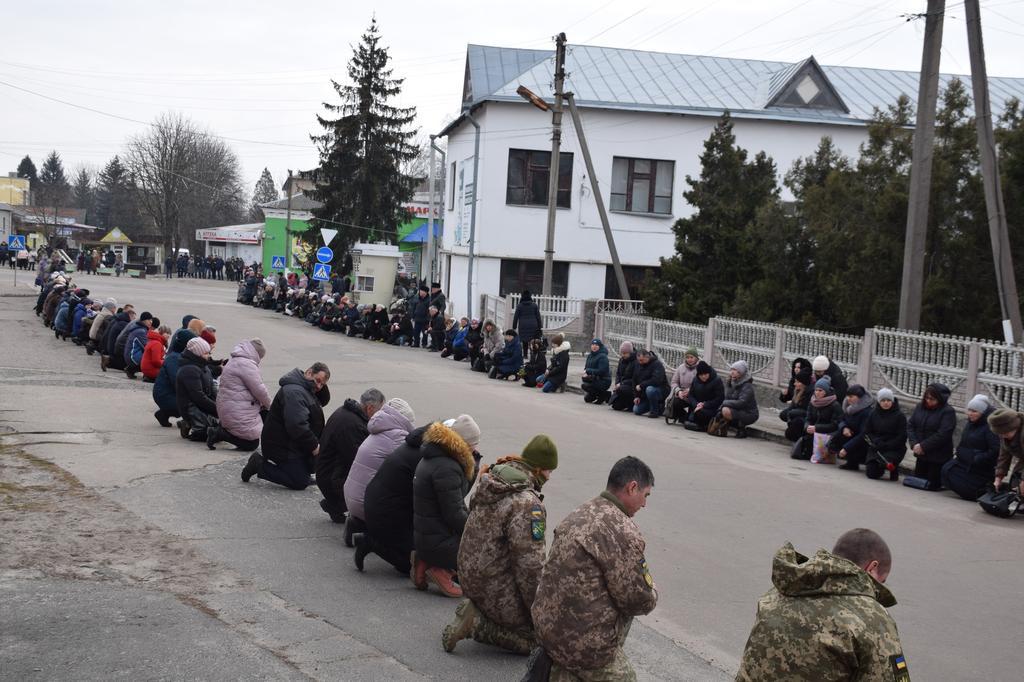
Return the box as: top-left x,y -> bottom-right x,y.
899,0 -> 946,330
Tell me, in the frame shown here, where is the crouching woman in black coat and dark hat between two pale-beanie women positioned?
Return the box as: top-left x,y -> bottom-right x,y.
906,383 -> 956,491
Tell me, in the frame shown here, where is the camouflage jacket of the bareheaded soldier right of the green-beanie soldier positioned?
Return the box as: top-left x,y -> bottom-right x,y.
534,493 -> 657,670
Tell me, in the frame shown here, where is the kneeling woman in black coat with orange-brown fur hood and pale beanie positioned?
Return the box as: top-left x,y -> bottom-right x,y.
413,415 -> 480,596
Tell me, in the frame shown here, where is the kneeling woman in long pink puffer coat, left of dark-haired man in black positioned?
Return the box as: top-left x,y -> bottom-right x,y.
206,339 -> 270,450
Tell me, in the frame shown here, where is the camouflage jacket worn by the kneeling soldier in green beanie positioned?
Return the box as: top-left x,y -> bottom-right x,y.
459,459 -> 547,630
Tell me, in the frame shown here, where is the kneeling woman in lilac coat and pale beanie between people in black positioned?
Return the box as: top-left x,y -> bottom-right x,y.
345,398 -> 416,520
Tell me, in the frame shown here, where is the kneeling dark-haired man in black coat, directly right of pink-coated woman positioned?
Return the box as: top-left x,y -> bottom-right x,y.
242,363 -> 331,491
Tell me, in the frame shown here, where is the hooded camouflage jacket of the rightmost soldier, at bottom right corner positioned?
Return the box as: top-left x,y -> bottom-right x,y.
736,543 -> 910,682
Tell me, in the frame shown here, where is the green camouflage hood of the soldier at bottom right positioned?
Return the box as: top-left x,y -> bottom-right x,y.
771,543 -> 896,607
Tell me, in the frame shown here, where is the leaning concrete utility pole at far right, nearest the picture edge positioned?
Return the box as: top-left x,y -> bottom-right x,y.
964,0 -> 1024,343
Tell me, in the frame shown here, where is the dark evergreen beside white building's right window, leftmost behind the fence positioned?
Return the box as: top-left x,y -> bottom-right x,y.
644,114 -> 778,323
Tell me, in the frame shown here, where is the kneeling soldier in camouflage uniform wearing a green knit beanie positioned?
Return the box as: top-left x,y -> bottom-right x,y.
441,434 -> 558,654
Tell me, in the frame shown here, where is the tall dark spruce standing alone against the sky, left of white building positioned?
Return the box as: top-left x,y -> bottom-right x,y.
312,19 -> 418,251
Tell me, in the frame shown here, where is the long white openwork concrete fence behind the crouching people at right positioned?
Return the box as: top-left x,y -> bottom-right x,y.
595,301 -> 1024,411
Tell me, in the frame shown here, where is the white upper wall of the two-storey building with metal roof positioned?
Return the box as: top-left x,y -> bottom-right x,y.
442,102 -> 866,298
